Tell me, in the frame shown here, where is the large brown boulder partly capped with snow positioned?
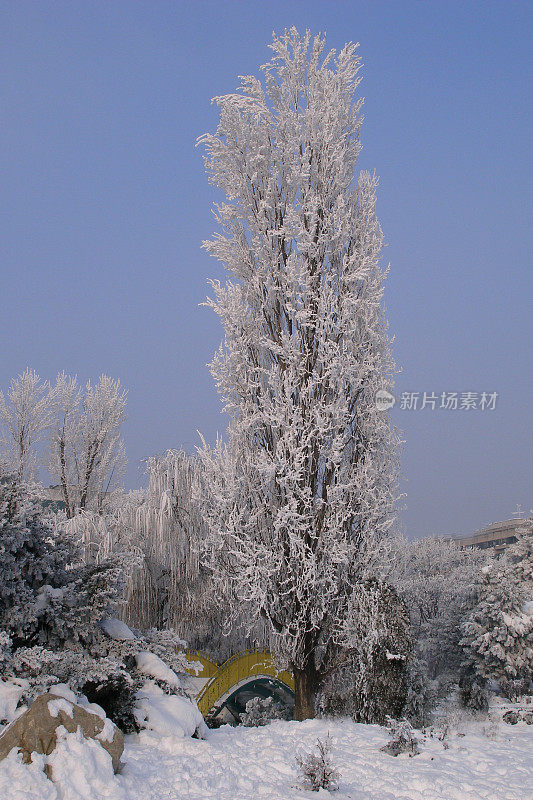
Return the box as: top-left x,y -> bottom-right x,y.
0,694 -> 124,772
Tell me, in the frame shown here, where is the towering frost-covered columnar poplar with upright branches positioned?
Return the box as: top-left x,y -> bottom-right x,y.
199,29 -> 397,719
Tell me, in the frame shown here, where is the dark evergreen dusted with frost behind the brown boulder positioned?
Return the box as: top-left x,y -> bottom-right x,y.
0,462 -> 189,729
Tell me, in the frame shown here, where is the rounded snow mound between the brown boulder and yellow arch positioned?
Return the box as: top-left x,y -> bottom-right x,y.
134,681 -> 207,739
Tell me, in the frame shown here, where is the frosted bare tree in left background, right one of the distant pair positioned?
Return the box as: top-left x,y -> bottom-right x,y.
48,373 -> 126,517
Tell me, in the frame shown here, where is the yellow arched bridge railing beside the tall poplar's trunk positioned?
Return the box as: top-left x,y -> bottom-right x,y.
187,650 -> 294,717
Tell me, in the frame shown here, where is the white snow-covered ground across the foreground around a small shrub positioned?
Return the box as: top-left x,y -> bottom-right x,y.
0,708 -> 533,800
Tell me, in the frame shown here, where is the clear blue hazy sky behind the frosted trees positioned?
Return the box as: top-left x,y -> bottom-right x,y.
0,0 -> 533,536
